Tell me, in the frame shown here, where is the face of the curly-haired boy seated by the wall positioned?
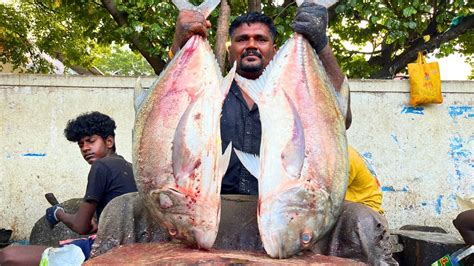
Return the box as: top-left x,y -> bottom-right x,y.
77,135 -> 114,164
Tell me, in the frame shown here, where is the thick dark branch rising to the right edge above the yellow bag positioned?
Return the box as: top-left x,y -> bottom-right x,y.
370,15 -> 474,79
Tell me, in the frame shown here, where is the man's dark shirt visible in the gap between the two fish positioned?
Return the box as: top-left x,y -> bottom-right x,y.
221,81 -> 262,195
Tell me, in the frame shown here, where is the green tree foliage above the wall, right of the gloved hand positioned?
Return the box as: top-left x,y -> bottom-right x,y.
331,0 -> 474,78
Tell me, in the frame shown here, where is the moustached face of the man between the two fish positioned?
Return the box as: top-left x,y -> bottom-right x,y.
229,22 -> 276,79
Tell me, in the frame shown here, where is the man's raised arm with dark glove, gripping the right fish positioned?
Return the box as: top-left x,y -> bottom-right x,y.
291,2 -> 352,129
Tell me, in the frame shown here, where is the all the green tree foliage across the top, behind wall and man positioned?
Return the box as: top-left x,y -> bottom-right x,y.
0,0 -> 474,78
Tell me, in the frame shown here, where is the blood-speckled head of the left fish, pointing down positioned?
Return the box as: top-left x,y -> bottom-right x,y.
148,188 -> 220,249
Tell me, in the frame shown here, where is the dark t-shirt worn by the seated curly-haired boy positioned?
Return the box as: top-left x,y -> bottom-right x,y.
84,154 -> 137,219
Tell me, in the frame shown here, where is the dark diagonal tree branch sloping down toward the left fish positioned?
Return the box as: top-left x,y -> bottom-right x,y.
102,0 -> 166,74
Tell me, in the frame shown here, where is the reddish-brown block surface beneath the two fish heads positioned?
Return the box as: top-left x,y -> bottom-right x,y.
84,243 -> 365,265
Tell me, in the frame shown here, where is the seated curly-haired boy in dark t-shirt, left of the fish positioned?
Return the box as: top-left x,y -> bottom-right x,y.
0,112 -> 137,265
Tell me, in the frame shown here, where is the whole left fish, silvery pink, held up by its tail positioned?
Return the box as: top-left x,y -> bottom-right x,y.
133,0 -> 235,249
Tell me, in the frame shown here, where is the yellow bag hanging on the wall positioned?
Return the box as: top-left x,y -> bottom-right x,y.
408,52 -> 443,106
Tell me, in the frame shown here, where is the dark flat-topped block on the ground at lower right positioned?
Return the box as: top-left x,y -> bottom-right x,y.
392,230 -> 464,266
